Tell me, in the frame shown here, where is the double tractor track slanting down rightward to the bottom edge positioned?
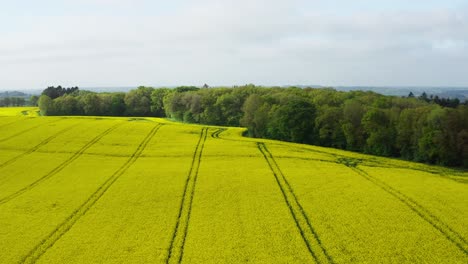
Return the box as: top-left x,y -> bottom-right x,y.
257,142 -> 334,263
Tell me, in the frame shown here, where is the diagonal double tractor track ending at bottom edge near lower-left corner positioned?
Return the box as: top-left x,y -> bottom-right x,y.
21,124 -> 163,263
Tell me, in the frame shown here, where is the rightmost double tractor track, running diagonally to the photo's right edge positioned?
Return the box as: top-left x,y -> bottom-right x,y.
349,167 -> 468,255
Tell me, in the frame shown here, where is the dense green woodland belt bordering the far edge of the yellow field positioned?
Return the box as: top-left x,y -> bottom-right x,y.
39,85 -> 468,167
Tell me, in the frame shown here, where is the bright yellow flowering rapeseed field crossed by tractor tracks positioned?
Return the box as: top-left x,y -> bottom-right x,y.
0,108 -> 468,263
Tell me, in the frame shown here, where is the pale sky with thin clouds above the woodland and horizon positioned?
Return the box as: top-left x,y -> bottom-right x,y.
0,0 -> 468,90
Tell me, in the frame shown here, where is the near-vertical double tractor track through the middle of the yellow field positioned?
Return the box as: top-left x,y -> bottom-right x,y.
166,127 -> 208,263
